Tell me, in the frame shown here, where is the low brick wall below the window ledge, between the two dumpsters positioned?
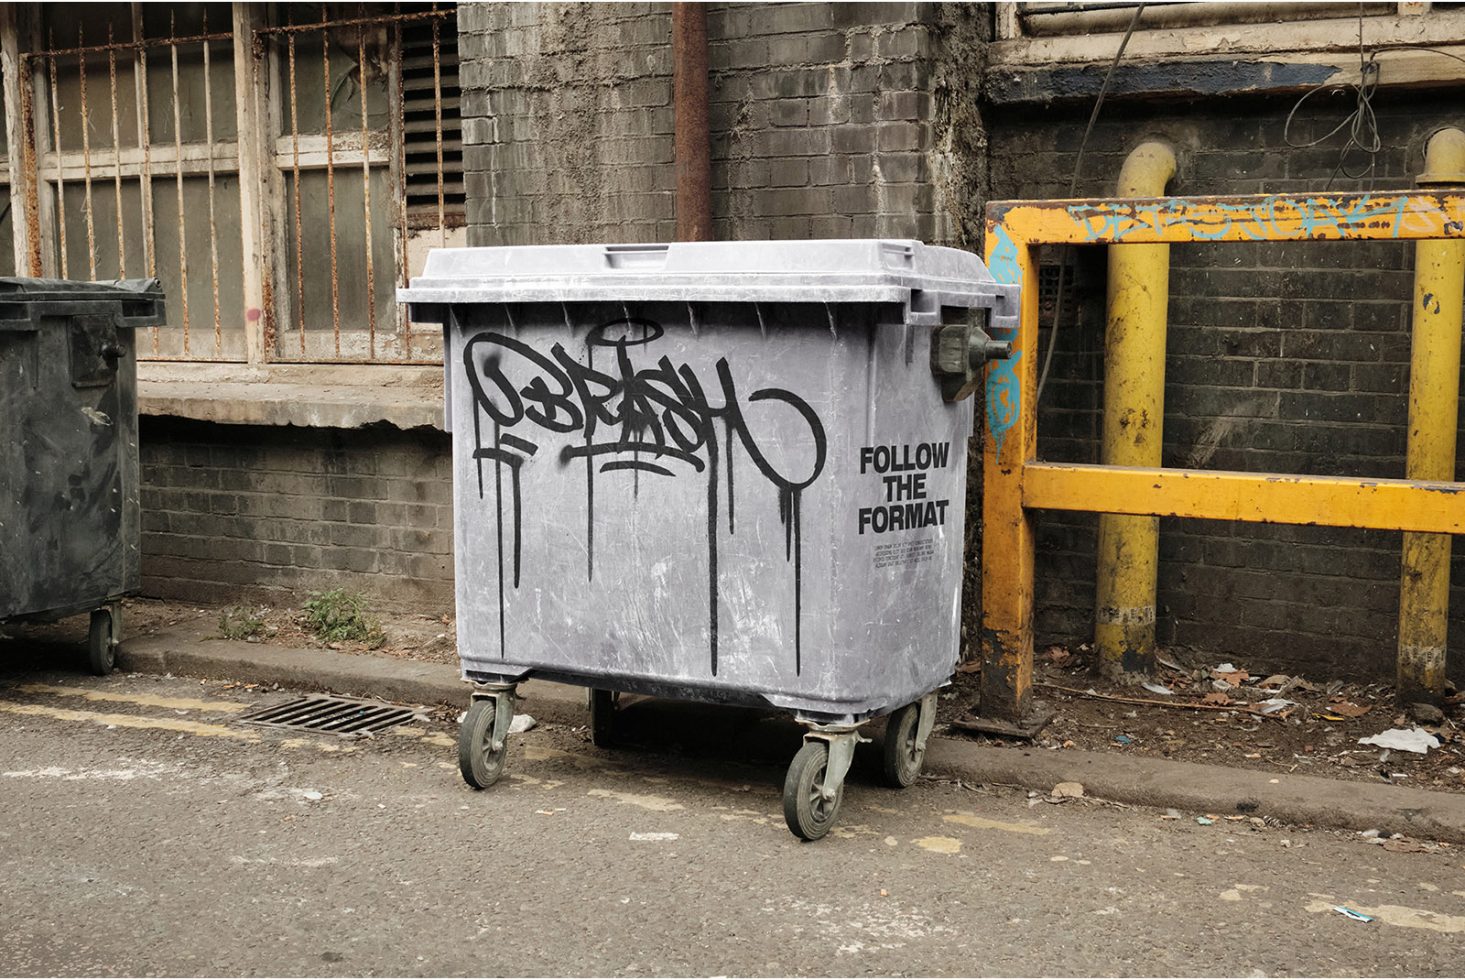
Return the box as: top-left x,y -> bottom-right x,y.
141,417 -> 453,615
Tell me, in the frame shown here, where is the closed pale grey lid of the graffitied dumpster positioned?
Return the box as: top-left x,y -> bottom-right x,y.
397,239 -> 1012,306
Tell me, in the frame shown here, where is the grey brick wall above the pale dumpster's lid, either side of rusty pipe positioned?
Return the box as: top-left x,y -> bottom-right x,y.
459,3 -> 986,251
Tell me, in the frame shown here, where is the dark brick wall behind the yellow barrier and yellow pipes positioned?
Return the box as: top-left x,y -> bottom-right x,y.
986,92 -> 1465,675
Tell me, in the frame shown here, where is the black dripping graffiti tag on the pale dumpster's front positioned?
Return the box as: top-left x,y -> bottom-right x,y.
463,318 -> 828,674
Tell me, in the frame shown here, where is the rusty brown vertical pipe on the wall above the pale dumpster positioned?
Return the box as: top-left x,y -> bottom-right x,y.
671,3 -> 712,242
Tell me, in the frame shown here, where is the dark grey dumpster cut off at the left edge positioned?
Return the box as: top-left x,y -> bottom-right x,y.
0,278 -> 163,674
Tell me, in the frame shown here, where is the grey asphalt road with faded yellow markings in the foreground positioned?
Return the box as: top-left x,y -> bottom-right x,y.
0,645 -> 1465,976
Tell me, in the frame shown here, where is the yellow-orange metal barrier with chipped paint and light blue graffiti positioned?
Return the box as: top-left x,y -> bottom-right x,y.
977,189 -> 1465,731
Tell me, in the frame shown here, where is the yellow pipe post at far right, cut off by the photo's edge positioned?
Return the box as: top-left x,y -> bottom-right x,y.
1396,129 -> 1465,705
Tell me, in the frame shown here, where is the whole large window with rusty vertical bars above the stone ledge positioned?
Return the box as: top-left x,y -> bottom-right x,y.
10,3 -> 464,363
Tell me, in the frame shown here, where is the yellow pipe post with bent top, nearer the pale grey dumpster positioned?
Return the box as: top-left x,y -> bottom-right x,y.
1094,142 -> 1175,680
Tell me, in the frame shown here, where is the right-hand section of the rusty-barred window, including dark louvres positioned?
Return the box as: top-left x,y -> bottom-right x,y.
258,3 -> 463,363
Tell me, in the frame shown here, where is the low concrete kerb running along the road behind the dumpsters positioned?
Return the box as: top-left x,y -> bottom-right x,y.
119,633 -> 1465,844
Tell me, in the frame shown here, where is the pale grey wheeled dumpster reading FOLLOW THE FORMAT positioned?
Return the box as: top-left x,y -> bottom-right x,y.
398,240 -> 1017,839
